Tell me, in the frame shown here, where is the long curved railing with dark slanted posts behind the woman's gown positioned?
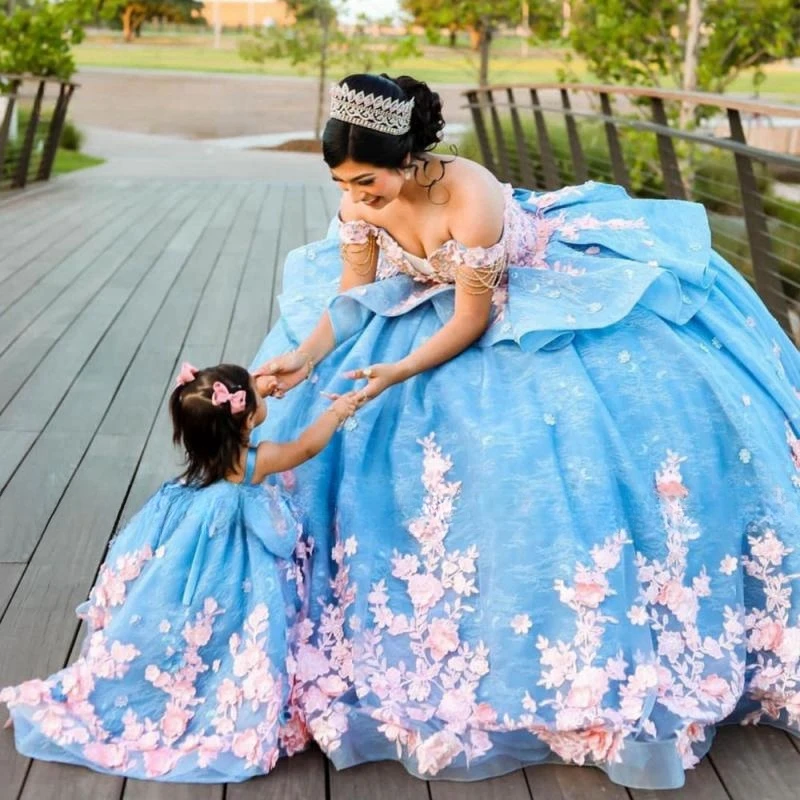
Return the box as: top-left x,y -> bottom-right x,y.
465,84 -> 800,340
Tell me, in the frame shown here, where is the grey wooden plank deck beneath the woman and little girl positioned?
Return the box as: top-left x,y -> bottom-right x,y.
0,175 -> 800,800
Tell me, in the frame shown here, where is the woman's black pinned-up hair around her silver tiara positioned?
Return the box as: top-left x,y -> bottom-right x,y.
322,74 -> 444,169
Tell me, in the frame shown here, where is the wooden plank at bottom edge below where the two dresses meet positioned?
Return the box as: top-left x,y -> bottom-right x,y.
225,747 -> 328,800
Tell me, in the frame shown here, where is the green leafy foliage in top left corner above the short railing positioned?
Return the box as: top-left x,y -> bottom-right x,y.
0,0 -> 89,80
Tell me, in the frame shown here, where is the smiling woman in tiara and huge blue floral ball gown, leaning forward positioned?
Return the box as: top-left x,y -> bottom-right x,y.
256,75 -> 800,788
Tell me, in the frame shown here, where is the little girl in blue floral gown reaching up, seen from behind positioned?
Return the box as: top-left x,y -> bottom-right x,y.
0,364 -> 359,783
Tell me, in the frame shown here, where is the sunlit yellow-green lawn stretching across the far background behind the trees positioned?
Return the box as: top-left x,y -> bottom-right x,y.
75,31 -> 800,103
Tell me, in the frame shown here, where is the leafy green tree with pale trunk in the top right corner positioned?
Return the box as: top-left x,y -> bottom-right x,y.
570,0 -> 800,97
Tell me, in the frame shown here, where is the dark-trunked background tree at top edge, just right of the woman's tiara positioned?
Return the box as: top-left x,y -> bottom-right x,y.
402,0 -> 560,86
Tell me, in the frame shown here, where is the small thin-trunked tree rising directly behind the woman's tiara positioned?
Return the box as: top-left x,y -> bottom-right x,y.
239,0 -> 417,139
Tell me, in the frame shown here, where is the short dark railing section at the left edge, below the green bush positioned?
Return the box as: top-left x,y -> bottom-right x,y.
0,74 -> 77,190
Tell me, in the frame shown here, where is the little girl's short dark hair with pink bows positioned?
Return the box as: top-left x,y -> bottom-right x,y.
169,364 -> 258,486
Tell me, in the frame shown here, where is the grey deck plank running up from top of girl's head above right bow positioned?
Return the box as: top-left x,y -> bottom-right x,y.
223,184 -> 286,364
